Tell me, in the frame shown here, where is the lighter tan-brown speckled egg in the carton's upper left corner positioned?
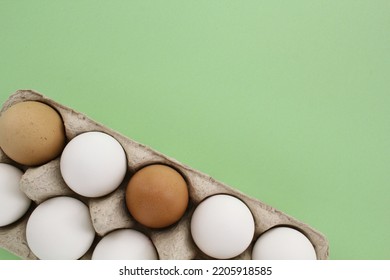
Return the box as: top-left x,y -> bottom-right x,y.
0,101 -> 65,166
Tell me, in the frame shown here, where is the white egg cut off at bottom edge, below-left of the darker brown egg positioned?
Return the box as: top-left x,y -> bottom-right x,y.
92,229 -> 158,260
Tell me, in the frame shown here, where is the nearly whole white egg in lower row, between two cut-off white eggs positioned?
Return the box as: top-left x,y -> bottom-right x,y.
26,196 -> 95,260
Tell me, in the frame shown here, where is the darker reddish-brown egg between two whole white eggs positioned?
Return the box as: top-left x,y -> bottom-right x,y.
126,164 -> 188,228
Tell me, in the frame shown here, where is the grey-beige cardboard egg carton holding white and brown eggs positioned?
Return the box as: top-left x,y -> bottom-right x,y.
0,90 -> 329,260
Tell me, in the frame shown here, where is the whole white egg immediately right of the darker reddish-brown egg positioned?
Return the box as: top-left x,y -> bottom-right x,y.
191,194 -> 255,259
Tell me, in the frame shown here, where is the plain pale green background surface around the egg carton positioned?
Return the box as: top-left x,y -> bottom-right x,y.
0,0 -> 390,259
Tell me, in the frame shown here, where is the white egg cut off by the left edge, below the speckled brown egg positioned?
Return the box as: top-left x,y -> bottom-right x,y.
0,163 -> 31,227
